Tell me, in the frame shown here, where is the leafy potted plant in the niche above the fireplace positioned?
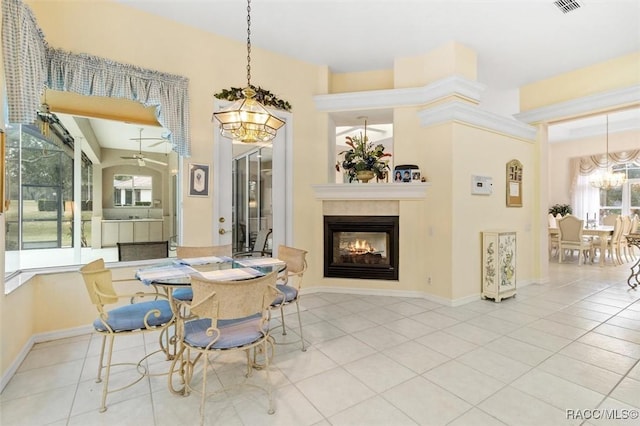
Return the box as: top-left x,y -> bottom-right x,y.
336,121 -> 391,183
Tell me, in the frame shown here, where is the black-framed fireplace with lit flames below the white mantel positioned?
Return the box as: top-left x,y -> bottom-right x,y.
324,216 -> 399,281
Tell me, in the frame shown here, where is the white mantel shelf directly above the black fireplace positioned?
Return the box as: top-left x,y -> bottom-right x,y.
311,182 -> 431,200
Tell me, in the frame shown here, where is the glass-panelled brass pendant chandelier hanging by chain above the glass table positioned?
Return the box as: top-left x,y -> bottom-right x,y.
213,0 -> 284,143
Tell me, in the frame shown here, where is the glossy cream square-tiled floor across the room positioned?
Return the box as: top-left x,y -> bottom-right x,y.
0,263 -> 640,426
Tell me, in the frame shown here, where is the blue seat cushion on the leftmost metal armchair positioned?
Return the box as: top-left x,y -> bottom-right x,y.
93,300 -> 173,332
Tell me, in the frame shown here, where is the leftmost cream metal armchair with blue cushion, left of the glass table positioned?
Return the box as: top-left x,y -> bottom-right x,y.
80,259 -> 174,412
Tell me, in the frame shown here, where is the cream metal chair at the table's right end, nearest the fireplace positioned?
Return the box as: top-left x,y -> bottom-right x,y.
271,245 -> 308,352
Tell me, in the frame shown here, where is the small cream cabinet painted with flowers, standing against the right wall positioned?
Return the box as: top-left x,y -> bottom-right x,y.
482,231 -> 517,302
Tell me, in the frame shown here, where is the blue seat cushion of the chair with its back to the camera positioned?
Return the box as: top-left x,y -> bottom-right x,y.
184,314 -> 269,349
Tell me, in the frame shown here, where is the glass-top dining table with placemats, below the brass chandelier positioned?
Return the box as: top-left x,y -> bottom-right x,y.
135,256 -> 286,395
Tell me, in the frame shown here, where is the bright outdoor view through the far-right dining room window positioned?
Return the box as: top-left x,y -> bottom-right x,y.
600,163 -> 640,217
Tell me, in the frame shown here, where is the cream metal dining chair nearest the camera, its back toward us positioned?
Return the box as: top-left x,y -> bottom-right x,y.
171,271 -> 278,425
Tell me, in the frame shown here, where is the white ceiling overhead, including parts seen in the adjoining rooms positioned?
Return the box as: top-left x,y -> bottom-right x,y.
60,0 -> 640,152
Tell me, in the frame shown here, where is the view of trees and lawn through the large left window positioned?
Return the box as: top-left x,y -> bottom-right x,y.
5,121 -> 93,274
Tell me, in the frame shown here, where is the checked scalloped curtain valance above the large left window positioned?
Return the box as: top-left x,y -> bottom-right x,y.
2,0 -> 191,157
